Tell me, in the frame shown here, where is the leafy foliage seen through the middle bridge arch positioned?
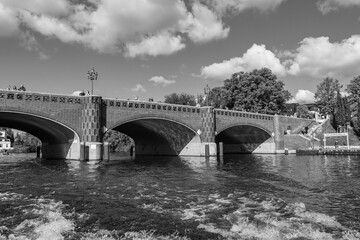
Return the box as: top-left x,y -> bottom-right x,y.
104,130 -> 135,152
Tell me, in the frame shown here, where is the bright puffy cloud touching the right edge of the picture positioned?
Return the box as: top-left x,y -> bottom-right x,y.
289,35 -> 360,78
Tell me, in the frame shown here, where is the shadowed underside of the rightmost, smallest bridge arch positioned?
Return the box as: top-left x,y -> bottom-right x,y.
215,125 -> 275,154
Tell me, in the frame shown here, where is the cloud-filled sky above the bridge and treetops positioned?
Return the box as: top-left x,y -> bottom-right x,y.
0,0 -> 360,103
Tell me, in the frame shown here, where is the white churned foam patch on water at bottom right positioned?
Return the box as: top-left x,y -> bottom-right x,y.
195,193 -> 360,240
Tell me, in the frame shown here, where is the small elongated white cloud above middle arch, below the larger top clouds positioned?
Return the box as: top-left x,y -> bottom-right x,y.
126,32 -> 185,57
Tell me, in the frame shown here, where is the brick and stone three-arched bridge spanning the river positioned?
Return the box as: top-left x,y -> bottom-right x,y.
0,90 -> 314,159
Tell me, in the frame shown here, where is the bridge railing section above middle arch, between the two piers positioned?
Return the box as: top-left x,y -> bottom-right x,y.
103,99 -> 200,114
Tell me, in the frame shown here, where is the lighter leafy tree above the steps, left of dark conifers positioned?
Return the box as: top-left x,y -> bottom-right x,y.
315,77 -> 342,118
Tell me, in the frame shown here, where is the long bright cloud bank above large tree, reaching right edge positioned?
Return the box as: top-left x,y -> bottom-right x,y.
201,35 -> 360,80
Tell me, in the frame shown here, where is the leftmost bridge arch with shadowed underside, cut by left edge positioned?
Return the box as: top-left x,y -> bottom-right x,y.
0,111 -> 80,159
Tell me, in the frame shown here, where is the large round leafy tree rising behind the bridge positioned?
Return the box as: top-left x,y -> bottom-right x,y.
224,68 -> 291,114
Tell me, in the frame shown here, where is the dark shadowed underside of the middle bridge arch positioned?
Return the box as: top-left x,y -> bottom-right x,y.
113,119 -> 200,156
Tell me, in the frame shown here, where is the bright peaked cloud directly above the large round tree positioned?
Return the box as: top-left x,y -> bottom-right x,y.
201,44 -> 286,80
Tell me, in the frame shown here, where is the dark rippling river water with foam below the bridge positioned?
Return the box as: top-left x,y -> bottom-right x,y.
0,155 -> 360,240
